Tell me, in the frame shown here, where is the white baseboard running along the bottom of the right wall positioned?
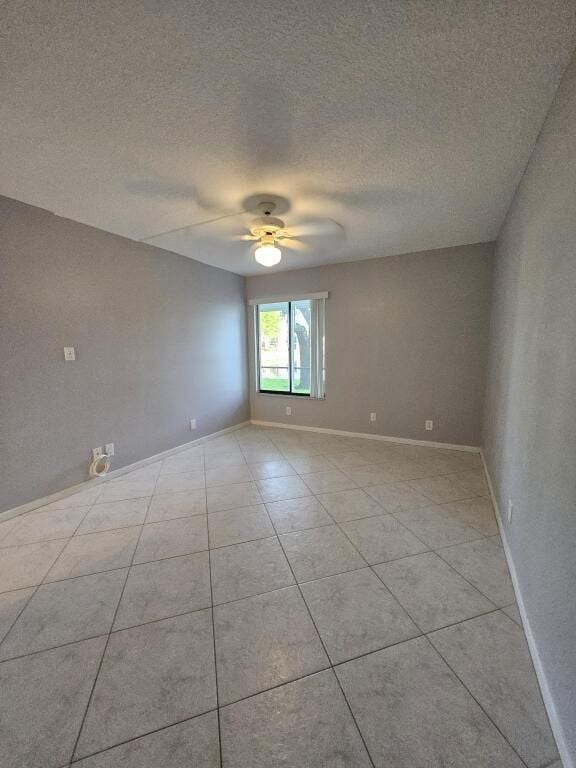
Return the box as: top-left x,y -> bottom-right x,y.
480,450 -> 576,768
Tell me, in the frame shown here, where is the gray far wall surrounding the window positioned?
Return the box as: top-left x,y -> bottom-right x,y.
247,243 -> 493,445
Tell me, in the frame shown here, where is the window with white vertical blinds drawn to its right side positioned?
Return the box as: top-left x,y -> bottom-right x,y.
254,298 -> 324,398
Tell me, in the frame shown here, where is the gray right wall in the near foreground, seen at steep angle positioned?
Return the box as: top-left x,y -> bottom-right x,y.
483,51 -> 576,768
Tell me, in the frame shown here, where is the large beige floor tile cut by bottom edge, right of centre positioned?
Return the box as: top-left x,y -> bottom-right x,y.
335,638 -> 522,768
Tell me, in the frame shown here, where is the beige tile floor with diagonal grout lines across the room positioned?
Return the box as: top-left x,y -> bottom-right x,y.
0,427 -> 559,768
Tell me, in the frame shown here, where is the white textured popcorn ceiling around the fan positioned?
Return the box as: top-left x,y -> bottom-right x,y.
0,0 -> 576,274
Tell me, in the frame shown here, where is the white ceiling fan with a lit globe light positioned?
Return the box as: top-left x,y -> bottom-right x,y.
145,194 -> 344,267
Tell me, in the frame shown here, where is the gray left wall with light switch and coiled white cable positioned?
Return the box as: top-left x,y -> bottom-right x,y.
0,198 -> 249,510
